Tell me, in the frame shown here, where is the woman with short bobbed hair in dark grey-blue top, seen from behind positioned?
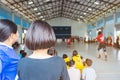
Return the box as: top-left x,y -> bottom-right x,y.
18,20 -> 70,80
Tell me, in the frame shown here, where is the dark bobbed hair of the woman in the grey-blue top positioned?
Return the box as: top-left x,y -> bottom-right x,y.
25,20 -> 56,50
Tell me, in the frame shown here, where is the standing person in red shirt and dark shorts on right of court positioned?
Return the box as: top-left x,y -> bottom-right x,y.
96,31 -> 108,60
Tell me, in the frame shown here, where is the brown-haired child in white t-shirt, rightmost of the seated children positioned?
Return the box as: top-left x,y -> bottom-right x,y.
82,59 -> 96,80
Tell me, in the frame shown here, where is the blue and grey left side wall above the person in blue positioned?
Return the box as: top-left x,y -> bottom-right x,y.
0,5 -> 30,43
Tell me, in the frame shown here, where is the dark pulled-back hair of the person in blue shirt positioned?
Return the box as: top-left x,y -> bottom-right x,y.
0,19 -> 17,42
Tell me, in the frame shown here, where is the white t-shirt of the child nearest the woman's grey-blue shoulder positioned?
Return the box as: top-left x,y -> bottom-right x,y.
68,67 -> 81,80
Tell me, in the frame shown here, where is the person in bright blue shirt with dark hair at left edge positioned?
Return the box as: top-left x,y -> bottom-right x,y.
0,19 -> 19,80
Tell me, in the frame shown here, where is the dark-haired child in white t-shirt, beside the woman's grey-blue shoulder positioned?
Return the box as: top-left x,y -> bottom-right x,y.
68,60 -> 81,80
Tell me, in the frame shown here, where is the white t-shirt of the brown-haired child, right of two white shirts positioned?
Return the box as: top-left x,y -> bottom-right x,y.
82,67 -> 96,80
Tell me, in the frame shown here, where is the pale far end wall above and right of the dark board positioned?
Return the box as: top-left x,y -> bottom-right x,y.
47,17 -> 87,37
